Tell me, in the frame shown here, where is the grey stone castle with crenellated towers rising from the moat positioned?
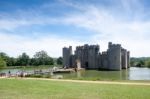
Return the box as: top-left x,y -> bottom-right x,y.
63,42 -> 130,70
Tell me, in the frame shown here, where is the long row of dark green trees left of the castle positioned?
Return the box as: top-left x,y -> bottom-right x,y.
0,50 -> 62,67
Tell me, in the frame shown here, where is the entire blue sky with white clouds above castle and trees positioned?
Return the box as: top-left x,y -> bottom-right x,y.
0,0 -> 150,57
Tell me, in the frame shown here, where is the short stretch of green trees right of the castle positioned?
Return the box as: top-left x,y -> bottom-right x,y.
130,57 -> 150,68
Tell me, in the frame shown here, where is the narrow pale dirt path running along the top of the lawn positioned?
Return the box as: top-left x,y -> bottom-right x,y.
1,78 -> 150,86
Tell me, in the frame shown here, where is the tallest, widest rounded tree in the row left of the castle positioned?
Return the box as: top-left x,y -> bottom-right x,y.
32,50 -> 54,65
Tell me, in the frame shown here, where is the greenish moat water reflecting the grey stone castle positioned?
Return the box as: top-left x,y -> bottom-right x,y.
0,67 -> 150,80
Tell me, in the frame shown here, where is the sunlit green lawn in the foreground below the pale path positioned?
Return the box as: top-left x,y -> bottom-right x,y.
0,79 -> 150,99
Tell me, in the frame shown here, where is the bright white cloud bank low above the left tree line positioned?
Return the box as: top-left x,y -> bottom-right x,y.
0,34 -> 84,57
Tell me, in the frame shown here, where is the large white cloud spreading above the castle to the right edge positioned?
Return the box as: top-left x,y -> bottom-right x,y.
60,3 -> 150,57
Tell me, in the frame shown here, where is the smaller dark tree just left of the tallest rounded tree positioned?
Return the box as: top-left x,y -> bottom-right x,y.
17,53 -> 30,66
